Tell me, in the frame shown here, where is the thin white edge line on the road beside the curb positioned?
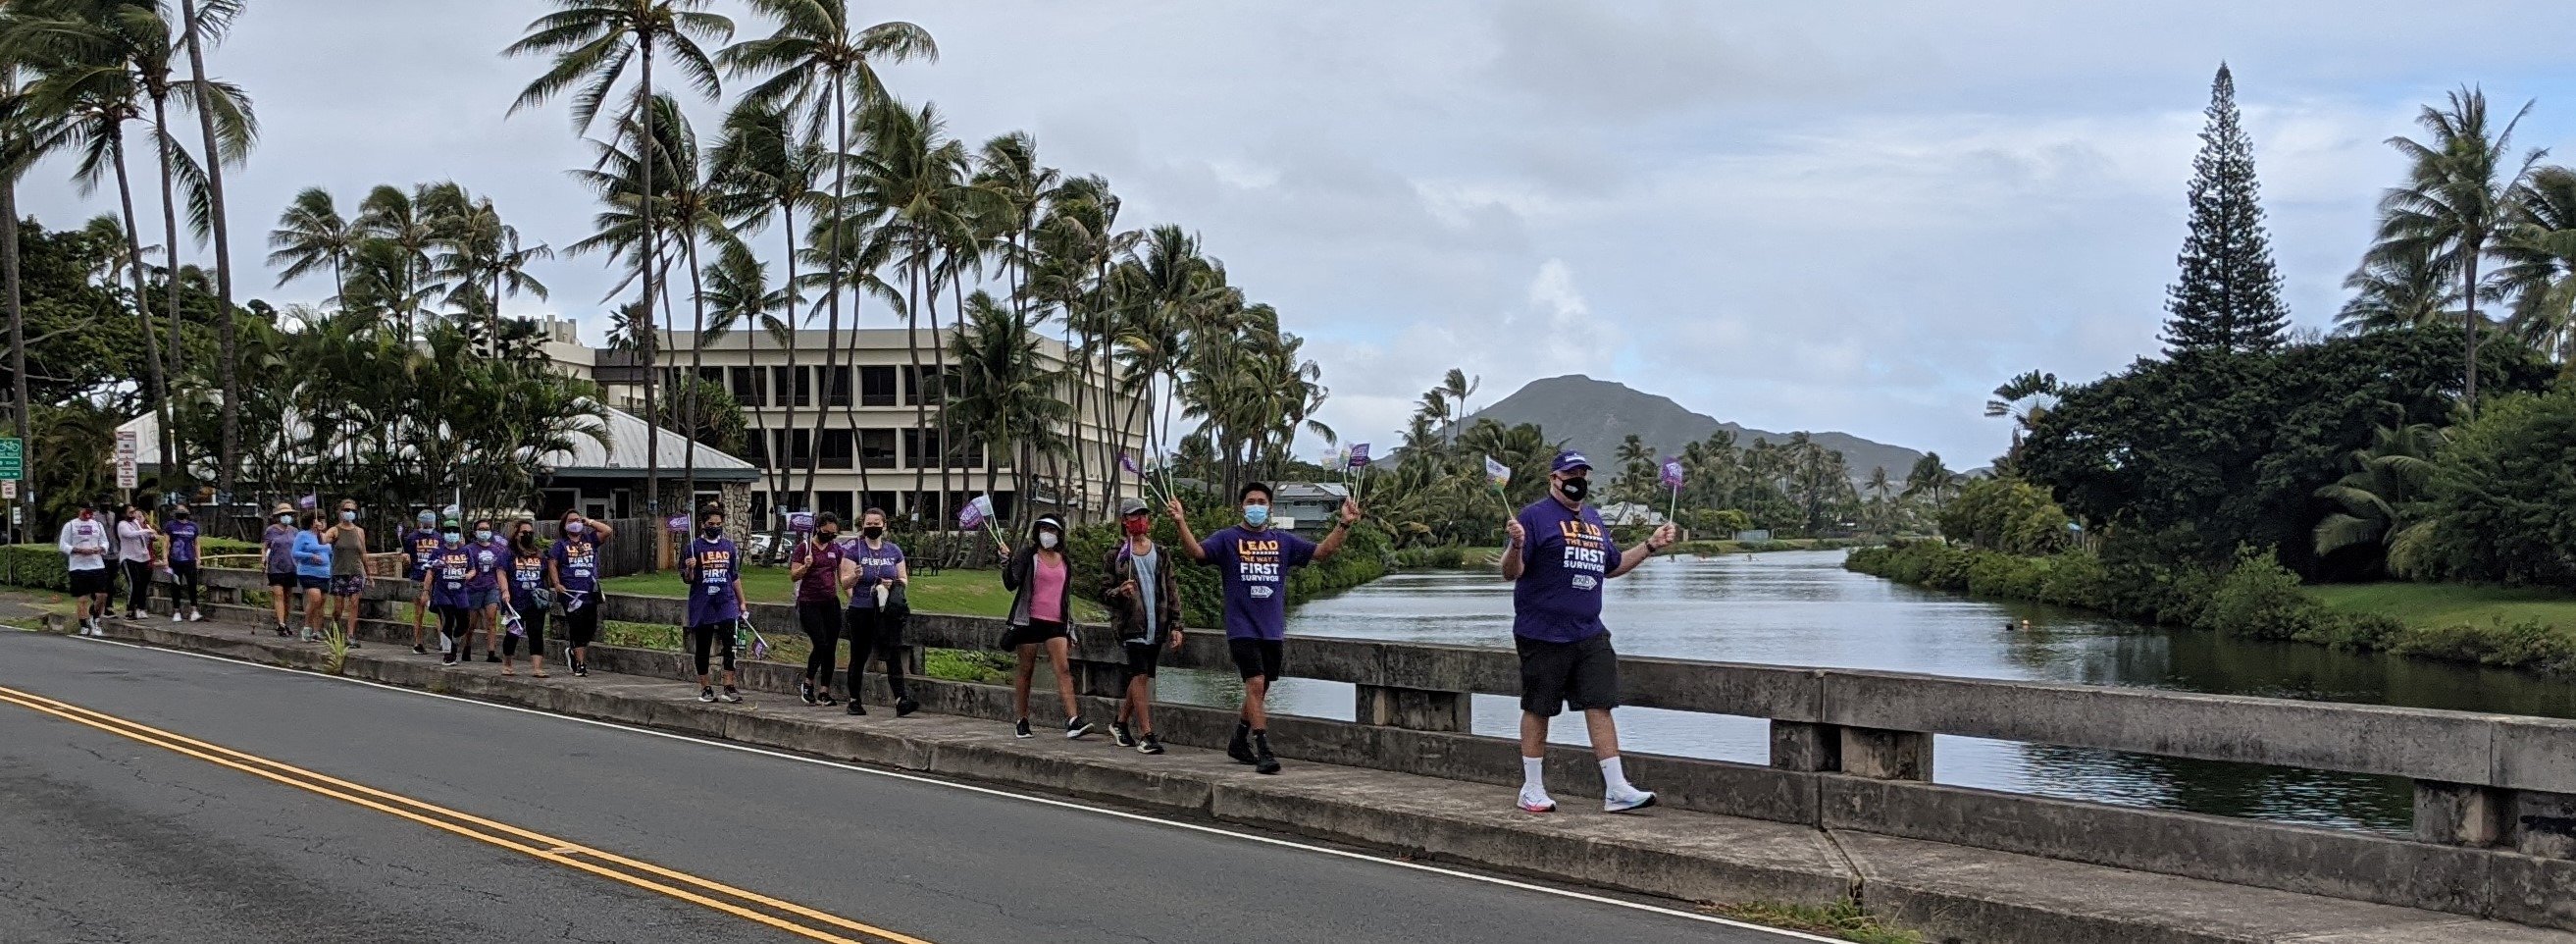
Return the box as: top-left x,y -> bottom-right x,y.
73,637 -> 1847,944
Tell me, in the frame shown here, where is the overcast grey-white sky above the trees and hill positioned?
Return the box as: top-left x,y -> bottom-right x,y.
21,0 -> 2576,467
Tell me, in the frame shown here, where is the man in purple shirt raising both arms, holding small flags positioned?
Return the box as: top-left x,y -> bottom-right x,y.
1169,483 -> 1361,774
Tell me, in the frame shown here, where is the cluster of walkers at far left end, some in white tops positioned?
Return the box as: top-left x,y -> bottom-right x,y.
54,500 -> 206,637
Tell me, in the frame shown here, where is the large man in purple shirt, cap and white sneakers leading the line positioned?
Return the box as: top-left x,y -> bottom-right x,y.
1502,451 -> 1674,813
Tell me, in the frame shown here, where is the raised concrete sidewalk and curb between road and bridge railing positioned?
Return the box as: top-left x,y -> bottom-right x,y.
70,619 -> 2576,944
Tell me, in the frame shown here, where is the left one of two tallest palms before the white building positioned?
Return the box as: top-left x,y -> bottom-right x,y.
502,0 -> 734,516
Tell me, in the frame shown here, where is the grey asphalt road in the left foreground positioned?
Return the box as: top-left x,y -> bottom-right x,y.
0,632 -> 1824,944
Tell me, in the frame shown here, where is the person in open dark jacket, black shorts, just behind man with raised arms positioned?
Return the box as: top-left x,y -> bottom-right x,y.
1100,498 -> 1180,753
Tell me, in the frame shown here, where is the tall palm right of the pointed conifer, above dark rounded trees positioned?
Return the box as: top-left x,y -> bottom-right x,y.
2370,87 -> 2545,415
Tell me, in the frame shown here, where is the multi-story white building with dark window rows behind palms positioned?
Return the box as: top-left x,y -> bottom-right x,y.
561,325 -> 1147,521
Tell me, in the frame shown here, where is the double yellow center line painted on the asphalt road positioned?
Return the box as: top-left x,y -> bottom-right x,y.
0,686 -> 930,944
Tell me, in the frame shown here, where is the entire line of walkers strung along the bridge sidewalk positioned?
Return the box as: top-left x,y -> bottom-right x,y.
59,451 -> 1677,813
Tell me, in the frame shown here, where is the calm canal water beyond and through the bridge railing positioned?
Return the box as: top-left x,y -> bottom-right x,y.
1161,551 -> 2576,836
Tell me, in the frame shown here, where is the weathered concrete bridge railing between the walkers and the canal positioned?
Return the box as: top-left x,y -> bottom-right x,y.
209,573 -> 2576,928
